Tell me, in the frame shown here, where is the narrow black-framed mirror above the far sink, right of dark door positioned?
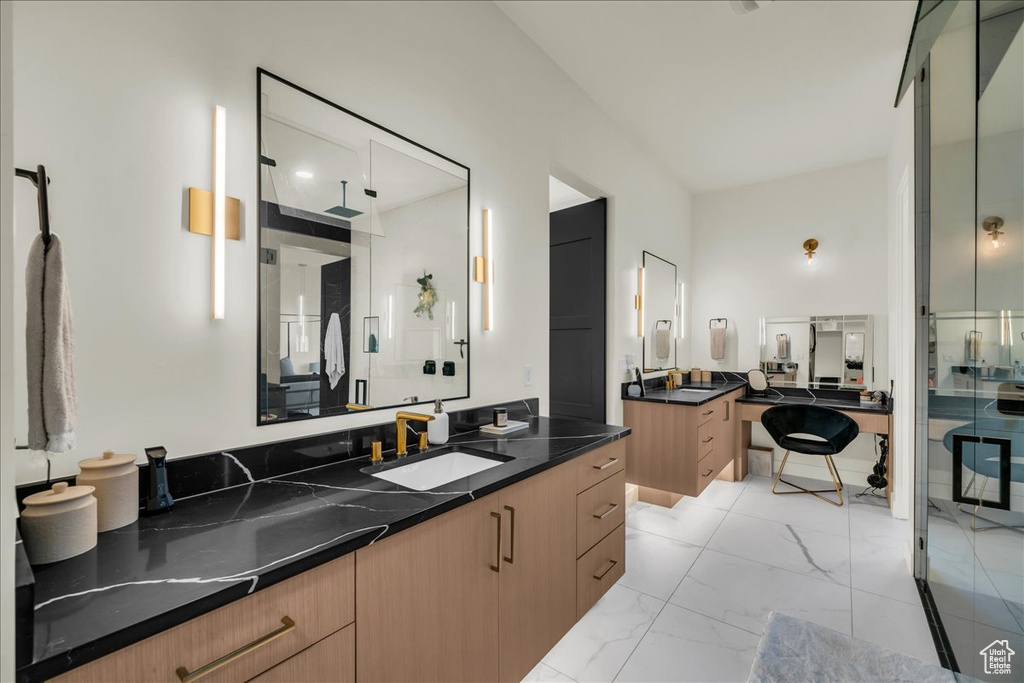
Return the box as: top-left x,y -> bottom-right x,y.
640,251 -> 679,373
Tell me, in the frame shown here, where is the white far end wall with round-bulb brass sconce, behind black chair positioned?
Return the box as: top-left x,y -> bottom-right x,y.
690,159 -> 888,484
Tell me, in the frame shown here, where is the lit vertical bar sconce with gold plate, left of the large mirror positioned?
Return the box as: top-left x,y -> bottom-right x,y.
188,106 -> 242,321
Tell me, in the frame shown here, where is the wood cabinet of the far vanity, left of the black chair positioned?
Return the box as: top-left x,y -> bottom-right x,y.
623,389 -> 742,498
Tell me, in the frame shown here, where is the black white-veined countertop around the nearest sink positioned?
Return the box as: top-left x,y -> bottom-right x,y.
18,417 -> 630,680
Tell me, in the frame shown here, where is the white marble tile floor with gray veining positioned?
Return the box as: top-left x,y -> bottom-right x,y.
524,476 -> 938,683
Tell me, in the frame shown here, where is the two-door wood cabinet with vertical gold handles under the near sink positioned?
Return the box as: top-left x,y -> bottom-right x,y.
355,463 -> 577,681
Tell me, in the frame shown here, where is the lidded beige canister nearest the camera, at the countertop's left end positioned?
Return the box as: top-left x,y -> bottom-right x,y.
22,481 -> 96,564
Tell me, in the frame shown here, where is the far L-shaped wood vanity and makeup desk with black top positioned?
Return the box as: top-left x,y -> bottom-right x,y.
623,372 -> 892,507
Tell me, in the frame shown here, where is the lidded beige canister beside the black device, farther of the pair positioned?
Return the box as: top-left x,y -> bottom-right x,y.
75,451 -> 138,531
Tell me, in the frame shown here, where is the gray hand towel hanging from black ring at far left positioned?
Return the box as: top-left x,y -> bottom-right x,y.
25,234 -> 78,453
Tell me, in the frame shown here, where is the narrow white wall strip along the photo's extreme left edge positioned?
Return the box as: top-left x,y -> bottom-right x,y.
0,2 -> 16,681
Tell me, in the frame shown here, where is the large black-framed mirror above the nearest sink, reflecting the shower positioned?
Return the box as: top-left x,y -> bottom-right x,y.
257,70 -> 469,425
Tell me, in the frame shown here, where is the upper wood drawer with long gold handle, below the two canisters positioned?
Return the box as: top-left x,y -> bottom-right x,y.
55,554 -> 355,683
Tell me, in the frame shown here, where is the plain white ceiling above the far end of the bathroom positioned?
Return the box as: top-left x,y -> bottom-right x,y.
496,0 -> 916,193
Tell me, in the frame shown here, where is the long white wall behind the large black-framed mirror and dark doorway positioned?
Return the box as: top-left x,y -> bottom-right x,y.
13,2 -> 690,481
